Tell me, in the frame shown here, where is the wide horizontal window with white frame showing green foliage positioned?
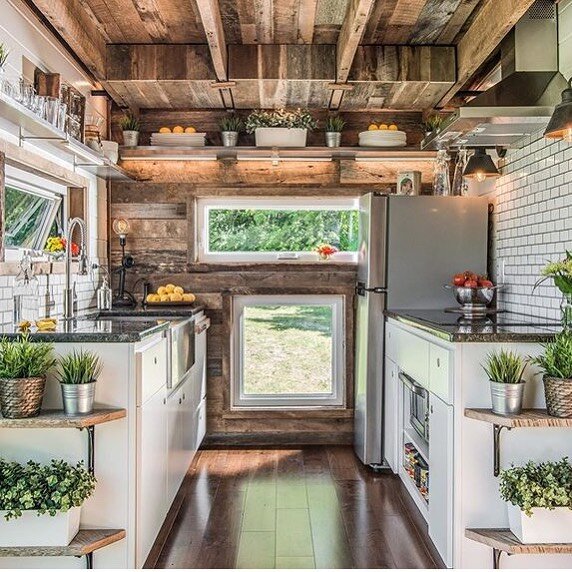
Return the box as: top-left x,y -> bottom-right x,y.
197,197 -> 358,262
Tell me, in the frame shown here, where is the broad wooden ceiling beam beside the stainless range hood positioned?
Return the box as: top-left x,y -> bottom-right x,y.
437,0 -> 534,107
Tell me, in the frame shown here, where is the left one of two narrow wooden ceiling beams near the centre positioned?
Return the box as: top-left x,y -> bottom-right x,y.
195,0 -> 234,109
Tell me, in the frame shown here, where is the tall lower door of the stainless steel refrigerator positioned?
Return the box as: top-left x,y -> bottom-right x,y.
354,290 -> 386,465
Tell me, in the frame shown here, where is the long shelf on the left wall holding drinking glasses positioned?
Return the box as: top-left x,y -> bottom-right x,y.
0,93 -> 133,181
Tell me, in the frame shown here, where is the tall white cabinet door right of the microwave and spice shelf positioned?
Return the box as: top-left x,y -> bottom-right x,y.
428,394 -> 453,567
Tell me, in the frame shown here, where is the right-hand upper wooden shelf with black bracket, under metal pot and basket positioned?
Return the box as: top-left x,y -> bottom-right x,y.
465,408 -> 572,477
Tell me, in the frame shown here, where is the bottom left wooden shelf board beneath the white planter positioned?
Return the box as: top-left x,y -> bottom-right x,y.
0,528 -> 125,557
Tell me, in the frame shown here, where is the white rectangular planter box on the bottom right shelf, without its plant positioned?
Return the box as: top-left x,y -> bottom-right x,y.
507,503 -> 572,544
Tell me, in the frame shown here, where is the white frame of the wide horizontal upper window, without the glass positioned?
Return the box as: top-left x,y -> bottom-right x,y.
196,197 -> 358,263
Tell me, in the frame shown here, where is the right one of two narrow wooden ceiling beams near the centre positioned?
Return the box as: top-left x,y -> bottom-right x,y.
330,0 -> 375,109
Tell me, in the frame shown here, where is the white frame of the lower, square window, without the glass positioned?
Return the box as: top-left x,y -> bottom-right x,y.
231,294 -> 346,410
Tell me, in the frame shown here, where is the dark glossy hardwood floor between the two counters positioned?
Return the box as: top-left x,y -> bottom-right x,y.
155,446 -> 442,568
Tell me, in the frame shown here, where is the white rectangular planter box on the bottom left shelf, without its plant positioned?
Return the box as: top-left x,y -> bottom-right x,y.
0,507 -> 81,547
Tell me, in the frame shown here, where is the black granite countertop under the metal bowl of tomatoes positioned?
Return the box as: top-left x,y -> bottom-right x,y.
385,309 -> 562,343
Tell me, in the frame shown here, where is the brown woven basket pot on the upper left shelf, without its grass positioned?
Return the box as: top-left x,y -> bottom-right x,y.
0,377 -> 46,419
